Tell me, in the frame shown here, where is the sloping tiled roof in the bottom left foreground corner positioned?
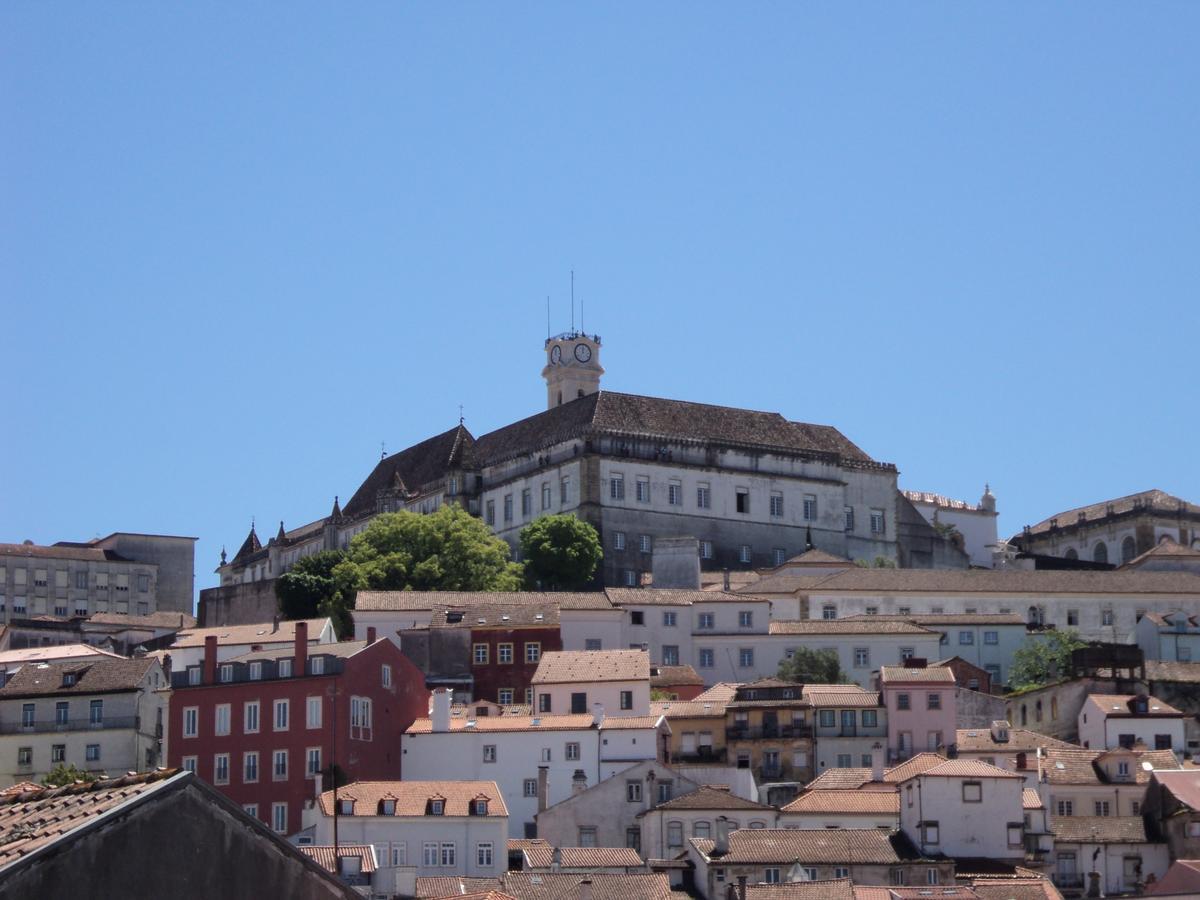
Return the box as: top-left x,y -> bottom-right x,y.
0,769 -> 180,868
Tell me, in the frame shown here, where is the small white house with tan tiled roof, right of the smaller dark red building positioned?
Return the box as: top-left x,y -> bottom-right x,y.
532,650 -> 650,715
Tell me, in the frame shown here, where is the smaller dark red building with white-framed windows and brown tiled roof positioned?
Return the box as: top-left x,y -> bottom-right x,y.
430,604 -> 563,706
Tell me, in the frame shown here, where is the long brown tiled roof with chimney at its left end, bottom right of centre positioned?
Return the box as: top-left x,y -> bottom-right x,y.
691,828 -> 920,865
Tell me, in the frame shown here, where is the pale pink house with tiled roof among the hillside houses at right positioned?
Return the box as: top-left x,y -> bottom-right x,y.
880,662 -> 958,762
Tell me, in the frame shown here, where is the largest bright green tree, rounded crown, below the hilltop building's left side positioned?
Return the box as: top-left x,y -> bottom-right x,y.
332,504 -> 522,600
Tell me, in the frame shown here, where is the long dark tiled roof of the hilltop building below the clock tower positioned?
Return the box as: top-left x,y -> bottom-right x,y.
475,391 -> 881,466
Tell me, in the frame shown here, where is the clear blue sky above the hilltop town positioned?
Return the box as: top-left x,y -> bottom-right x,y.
0,1 -> 1200,600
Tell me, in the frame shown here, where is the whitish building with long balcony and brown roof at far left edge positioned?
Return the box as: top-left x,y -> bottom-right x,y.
0,658 -> 167,786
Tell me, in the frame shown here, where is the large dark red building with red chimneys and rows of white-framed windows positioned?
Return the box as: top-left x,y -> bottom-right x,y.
167,623 -> 430,834
